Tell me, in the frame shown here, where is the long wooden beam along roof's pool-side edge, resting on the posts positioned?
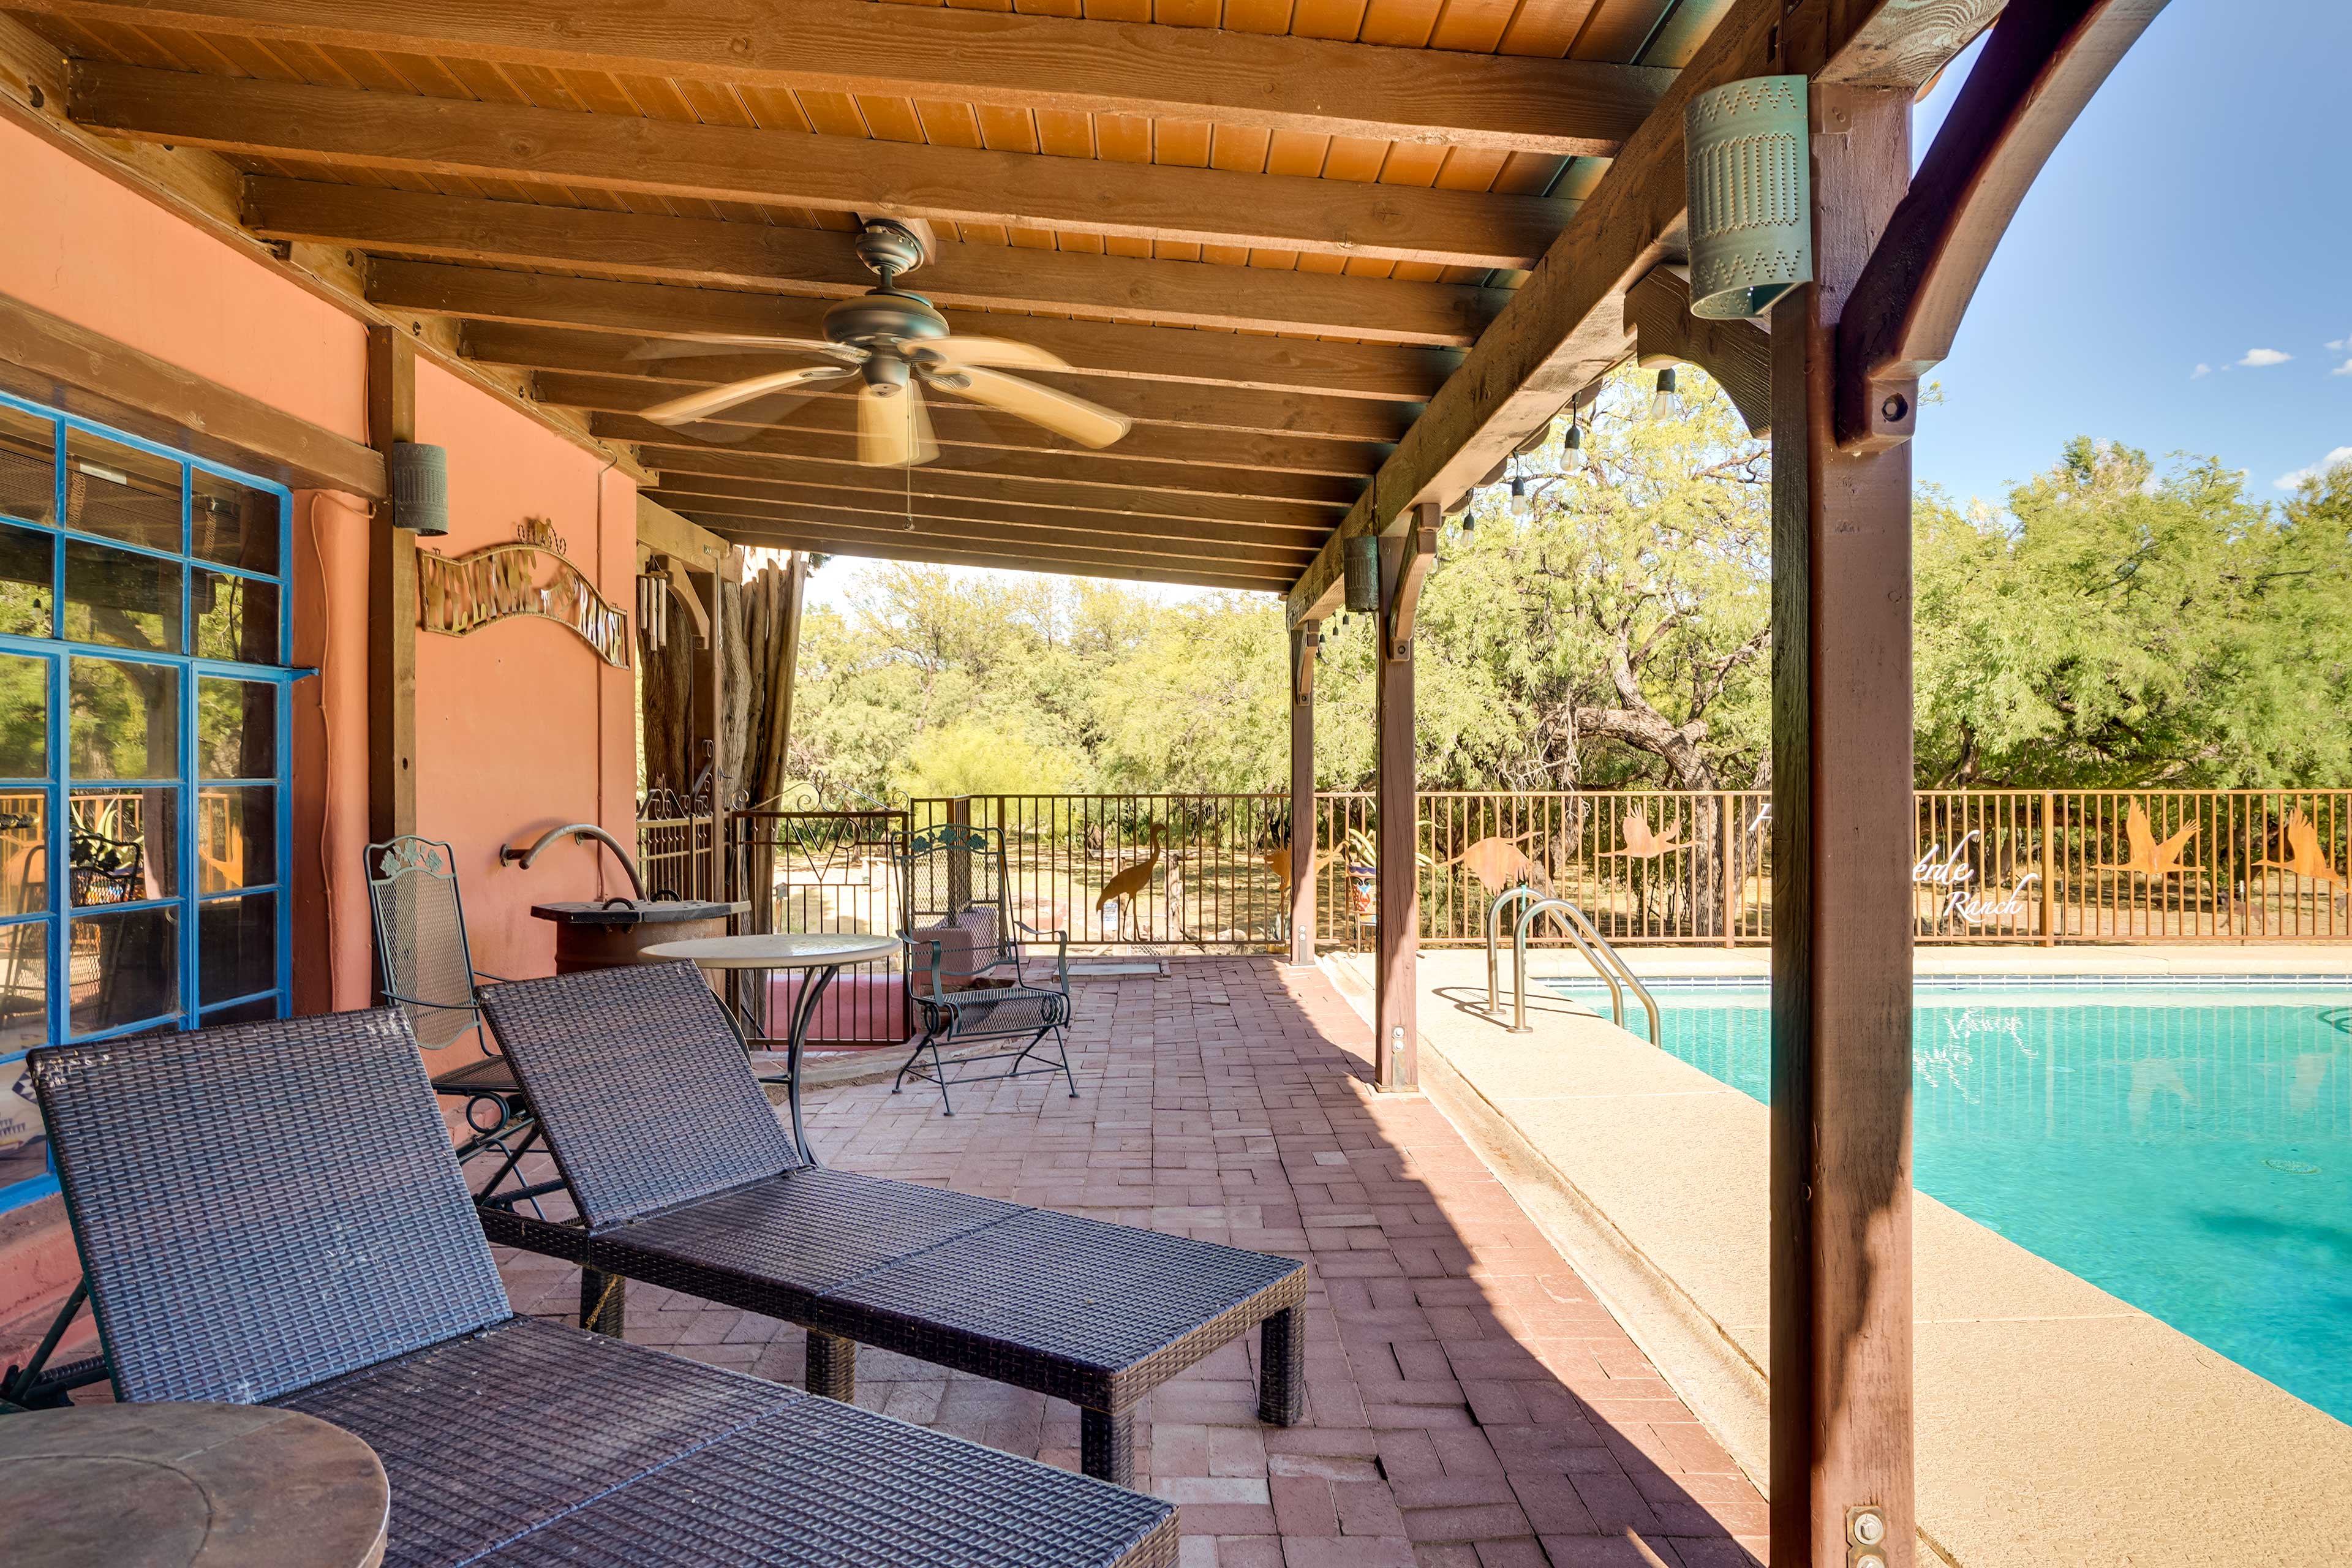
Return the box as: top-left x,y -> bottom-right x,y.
1289,0 -> 2002,625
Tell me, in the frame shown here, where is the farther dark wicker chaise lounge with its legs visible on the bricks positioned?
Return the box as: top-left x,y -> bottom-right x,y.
482,964 -> 1305,1481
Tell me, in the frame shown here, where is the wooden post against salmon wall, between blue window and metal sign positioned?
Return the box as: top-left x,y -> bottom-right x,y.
367,326 -> 417,844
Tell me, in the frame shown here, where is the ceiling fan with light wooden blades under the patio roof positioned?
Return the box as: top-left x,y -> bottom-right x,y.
644,221 -> 1131,468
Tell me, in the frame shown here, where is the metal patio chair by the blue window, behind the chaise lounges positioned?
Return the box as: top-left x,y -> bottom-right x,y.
367,835 -> 552,1192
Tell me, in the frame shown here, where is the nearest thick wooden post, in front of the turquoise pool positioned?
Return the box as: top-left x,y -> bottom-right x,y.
1771,82 -> 1917,1568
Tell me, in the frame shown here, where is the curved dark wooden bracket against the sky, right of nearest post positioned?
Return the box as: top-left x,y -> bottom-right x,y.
1837,0 -> 2164,451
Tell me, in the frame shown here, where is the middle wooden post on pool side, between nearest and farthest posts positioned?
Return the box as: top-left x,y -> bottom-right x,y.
1374,501 -> 1437,1088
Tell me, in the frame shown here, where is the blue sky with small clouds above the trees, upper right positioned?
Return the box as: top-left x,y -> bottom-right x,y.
1912,0 -> 2352,501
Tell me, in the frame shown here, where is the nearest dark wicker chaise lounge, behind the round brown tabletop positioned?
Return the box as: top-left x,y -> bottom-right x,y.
29,1011 -> 1176,1568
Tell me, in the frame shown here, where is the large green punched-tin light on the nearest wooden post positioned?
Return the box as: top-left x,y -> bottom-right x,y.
1682,75 -> 1814,320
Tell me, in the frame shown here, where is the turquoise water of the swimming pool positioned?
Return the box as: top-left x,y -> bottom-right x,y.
1557,978 -> 2352,1420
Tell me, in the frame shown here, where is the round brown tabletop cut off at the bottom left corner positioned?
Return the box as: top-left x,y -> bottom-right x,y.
0,1403 -> 390,1568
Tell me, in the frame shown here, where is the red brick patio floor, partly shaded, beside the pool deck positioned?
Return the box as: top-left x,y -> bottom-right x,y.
501,959 -> 1764,1568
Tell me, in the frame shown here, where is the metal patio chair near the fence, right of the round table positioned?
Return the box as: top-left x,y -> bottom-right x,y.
889,823 -> 1077,1117
